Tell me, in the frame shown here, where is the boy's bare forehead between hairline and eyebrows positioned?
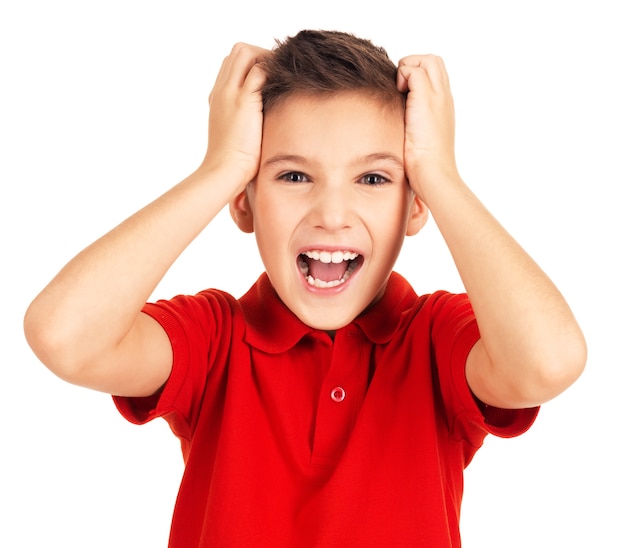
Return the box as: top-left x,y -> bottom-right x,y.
261,92 -> 404,158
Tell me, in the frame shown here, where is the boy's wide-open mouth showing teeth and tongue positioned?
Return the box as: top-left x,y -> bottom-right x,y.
298,249 -> 363,288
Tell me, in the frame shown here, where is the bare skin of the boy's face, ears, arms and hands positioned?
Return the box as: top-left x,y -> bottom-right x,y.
20,44 -> 586,408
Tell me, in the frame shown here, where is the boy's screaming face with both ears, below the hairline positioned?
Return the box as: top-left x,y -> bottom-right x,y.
231,93 -> 427,331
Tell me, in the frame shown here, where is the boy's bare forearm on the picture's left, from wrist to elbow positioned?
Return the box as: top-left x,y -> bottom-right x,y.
25,165 -> 235,372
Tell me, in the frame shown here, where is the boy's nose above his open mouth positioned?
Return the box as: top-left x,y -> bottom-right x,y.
310,182 -> 355,232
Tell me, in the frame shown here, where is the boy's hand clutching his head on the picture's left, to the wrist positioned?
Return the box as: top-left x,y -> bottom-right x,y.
201,43 -> 270,194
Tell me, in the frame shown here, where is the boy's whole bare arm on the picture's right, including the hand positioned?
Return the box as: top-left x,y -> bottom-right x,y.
398,55 -> 586,408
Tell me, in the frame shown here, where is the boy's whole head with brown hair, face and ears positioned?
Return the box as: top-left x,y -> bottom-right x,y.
230,31 -> 427,332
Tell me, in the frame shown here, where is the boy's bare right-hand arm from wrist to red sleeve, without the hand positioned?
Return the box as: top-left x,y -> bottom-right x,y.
422,177 -> 586,406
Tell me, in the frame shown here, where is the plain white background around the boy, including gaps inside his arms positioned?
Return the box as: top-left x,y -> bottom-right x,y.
0,0 -> 626,548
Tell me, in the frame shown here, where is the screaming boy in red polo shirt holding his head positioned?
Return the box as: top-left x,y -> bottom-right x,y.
25,31 -> 586,548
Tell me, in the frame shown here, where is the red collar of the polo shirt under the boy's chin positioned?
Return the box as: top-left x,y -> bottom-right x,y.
239,272 -> 417,354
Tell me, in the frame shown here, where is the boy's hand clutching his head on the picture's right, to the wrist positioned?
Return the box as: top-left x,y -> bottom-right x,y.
397,55 -> 459,201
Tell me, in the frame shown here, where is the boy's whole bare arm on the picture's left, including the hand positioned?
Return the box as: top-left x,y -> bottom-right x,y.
24,44 -> 266,396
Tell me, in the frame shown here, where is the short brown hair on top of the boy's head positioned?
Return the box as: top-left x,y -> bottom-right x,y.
262,30 -> 404,113
